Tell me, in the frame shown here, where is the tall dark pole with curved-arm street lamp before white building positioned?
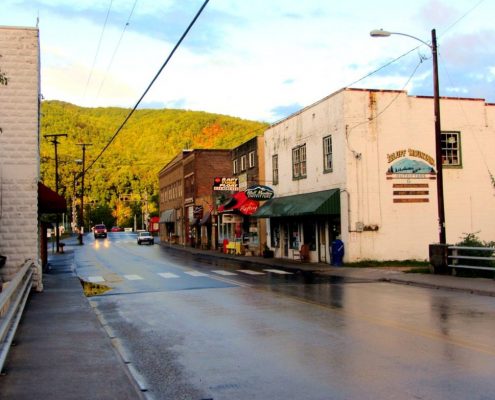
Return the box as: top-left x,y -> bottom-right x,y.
370,29 -> 447,244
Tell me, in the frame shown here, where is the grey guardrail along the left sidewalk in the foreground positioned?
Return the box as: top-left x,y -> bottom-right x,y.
0,260 -> 33,372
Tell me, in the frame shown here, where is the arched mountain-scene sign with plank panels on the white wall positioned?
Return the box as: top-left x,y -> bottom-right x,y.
387,149 -> 436,203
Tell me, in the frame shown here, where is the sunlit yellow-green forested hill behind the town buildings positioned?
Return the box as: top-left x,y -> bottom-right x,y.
41,101 -> 268,212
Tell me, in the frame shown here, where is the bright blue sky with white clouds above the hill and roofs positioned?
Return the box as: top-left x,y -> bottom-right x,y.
0,0 -> 495,123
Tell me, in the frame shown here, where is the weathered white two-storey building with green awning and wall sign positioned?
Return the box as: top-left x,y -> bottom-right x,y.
257,89 -> 495,262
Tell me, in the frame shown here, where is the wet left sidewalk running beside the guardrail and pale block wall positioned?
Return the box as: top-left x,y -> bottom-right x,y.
0,241 -> 143,400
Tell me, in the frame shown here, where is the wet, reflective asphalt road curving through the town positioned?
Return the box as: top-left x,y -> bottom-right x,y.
75,232 -> 495,400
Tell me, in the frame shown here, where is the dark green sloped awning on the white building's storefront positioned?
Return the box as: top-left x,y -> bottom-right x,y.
253,189 -> 340,218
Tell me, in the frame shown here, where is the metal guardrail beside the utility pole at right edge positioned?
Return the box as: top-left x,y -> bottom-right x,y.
447,246 -> 495,272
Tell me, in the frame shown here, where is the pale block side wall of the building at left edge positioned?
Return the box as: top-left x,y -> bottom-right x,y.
0,27 -> 40,286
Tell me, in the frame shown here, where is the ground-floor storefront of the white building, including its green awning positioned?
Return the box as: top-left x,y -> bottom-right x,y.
253,189 -> 341,263
